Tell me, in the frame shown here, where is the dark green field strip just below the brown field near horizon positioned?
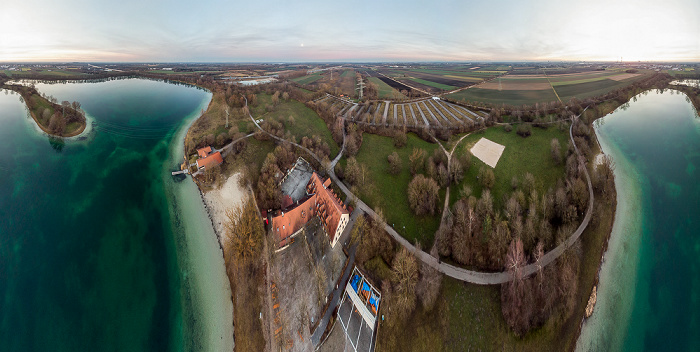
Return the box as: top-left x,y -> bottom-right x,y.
447,88 -> 559,105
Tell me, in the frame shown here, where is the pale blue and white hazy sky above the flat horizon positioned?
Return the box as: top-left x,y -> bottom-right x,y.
0,0 -> 700,62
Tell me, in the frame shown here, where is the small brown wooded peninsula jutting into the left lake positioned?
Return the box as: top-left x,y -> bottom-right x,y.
0,81 -> 87,138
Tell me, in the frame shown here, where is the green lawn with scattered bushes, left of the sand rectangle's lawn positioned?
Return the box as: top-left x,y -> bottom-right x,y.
356,133 -> 444,246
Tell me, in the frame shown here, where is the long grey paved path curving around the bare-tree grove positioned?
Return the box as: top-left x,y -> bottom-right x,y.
244,97 -> 594,285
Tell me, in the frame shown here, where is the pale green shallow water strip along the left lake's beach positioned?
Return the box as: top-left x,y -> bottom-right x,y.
163,91 -> 234,351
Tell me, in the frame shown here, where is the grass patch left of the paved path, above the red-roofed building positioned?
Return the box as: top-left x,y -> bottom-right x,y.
251,93 -> 340,159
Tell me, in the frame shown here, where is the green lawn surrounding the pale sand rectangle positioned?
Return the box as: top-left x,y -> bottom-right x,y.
450,126 -> 569,209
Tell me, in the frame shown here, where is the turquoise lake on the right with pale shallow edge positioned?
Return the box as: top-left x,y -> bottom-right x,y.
577,90 -> 700,351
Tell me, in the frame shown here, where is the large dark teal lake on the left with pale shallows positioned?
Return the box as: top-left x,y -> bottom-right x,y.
0,79 -> 232,351
